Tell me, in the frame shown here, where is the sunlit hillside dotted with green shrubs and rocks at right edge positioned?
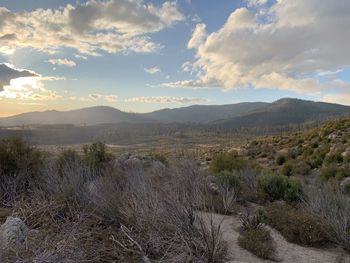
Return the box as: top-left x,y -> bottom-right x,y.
240,118 -> 350,181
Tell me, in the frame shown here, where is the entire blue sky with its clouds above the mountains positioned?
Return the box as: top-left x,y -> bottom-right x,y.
0,0 -> 350,117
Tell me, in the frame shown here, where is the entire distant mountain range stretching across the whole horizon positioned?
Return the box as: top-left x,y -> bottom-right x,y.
0,98 -> 350,128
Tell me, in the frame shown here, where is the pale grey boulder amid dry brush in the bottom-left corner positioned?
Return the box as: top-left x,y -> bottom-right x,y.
0,217 -> 30,250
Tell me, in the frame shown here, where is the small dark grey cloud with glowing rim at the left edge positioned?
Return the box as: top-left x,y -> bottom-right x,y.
0,63 -> 40,92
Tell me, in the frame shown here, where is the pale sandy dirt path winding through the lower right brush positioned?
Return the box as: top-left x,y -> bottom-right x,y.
201,214 -> 350,263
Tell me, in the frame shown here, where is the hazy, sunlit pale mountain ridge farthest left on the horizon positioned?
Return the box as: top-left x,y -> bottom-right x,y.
0,106 -> 150,126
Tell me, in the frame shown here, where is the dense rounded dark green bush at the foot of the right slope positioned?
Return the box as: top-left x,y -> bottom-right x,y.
258,173 -> 303,203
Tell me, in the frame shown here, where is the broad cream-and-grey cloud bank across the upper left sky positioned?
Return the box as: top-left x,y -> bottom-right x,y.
0,0 -> 184,56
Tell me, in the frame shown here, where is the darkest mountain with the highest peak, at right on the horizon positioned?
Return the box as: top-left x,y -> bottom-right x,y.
213,98 -> 350,128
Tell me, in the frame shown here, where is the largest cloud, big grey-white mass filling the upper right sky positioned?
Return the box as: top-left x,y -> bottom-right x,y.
165,0 -> 350,94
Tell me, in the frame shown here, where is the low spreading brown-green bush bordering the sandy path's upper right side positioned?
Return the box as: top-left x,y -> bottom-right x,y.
266,203 -> 330,247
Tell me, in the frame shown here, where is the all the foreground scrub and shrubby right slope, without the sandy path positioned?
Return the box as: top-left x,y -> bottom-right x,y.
0,120 -> 350,262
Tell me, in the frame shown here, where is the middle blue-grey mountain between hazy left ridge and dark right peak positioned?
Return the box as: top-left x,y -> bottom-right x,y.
145,102 -> 268,124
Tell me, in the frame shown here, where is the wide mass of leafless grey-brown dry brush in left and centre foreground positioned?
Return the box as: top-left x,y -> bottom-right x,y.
0,150 -> 226,262
